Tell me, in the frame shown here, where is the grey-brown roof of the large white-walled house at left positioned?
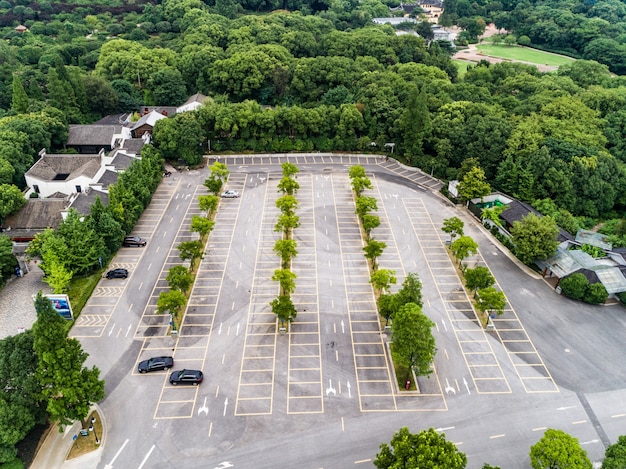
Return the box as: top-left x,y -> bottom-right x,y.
26,155 -> 101,181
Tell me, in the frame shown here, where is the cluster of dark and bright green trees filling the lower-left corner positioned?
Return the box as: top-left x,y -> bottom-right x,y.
0,292 -> 104,463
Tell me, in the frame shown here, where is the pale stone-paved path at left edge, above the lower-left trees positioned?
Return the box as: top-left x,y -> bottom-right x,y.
0,261 -> 52,339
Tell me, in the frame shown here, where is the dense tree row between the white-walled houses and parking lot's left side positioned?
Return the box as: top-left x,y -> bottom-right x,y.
27,146 -> 163,293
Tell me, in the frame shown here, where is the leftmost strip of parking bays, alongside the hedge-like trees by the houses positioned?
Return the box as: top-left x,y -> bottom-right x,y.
70,178 -> 180,338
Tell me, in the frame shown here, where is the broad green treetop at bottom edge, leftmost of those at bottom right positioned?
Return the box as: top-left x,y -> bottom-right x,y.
374,427 -> 467,469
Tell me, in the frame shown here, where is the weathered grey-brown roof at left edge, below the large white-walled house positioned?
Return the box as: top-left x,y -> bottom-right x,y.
2,198 -> 68,232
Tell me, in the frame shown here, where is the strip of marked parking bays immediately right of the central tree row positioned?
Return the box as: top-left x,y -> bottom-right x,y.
286,173 -> 324,414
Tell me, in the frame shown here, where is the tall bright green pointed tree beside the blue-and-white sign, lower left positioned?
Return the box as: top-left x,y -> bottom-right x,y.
33,291 -> 104,431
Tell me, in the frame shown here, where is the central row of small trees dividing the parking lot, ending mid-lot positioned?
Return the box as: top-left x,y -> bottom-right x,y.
270,162 -> 300,326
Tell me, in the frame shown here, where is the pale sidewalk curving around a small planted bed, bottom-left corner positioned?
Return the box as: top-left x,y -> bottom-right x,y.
28,404 -> 107,469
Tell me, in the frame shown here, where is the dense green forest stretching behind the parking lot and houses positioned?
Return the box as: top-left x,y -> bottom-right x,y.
0,0 -> 626,236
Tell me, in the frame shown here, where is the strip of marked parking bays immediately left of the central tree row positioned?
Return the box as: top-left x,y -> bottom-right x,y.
235,173 -> 282,415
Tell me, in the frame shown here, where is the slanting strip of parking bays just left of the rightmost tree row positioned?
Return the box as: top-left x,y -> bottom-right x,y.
403,198 -> 511,394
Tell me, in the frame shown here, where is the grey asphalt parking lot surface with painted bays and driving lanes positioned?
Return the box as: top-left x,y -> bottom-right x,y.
72,155 -> 626,468
